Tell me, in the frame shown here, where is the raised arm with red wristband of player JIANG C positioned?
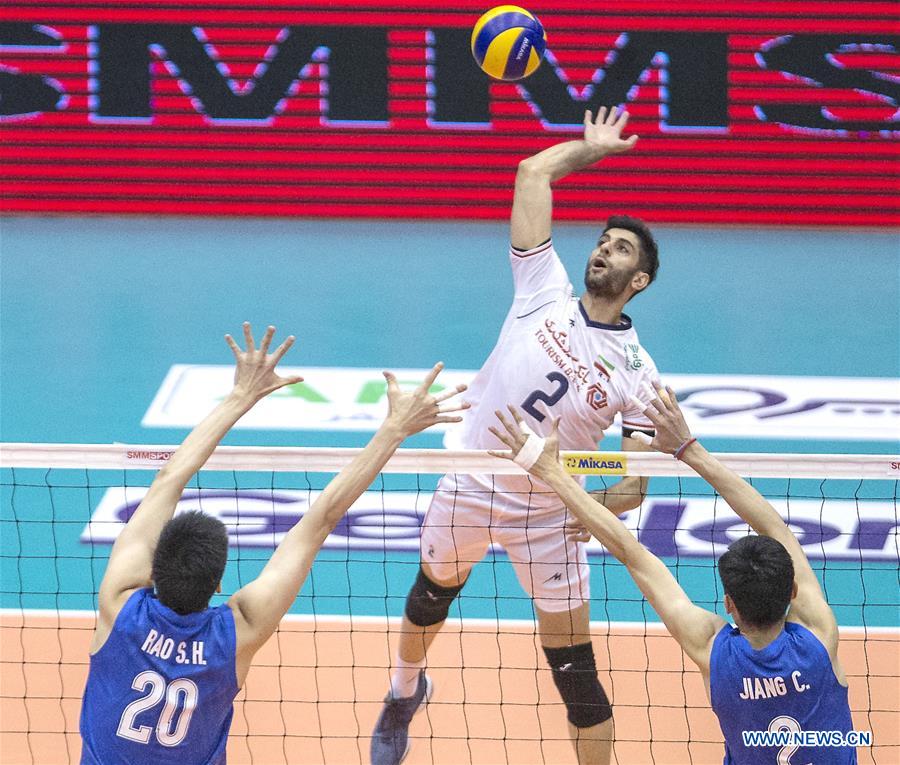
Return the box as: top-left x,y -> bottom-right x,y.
632,388 -> 840,671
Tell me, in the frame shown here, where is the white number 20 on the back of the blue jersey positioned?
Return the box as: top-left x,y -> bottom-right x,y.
116,670 -> 200,746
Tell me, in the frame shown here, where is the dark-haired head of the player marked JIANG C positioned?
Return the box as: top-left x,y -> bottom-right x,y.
719,535 -> 794,627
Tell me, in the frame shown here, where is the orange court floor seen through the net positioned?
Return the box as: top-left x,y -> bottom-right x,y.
0,612 -> 900,765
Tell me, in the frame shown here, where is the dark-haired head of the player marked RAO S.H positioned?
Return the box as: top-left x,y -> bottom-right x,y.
152,510 -> 228,614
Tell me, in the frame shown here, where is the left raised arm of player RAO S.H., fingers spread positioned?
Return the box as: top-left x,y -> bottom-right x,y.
91,322 -> 303,652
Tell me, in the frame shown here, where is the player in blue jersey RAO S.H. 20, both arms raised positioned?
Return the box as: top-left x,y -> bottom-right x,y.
80,324 -> 467,765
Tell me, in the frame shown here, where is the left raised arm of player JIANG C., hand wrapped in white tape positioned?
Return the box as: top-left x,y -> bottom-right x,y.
490,406 -> 725,675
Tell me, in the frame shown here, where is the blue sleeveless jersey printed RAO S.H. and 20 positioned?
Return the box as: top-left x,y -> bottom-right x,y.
80,588 -> 240,765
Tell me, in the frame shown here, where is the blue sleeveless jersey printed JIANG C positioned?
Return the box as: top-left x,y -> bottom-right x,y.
709,622 -> 856,765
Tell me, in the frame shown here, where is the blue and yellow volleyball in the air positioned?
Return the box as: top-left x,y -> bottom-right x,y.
472,5 -> 547,81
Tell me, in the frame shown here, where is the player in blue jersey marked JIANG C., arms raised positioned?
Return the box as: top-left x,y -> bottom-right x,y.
492,388 -> 857,765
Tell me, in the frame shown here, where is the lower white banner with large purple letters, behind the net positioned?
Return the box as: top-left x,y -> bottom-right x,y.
81,487 -> 897,562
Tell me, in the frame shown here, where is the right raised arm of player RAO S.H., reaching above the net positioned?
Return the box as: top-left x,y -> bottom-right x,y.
228,363 -> 468,682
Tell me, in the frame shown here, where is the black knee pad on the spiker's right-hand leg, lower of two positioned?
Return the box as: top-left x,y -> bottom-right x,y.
544,643 -> 612,728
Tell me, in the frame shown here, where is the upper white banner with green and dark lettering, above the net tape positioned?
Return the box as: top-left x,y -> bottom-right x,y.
142,364 -> 900,442
